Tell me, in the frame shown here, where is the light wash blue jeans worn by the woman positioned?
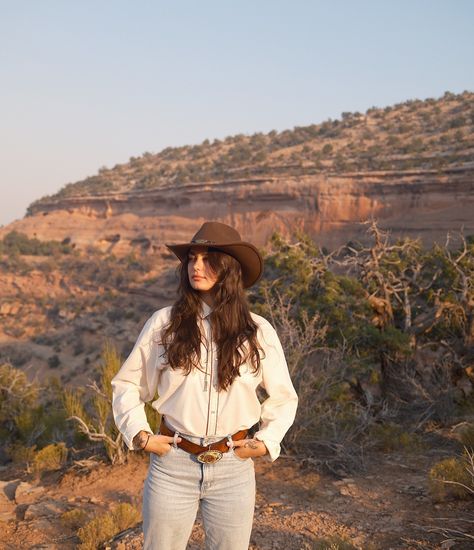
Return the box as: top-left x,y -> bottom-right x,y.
143,436 -> 255,550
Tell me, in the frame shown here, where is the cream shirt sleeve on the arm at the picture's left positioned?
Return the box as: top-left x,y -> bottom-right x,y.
111,312 -> 163,450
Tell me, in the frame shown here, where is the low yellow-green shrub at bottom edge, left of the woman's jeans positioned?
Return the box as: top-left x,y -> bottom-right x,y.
77,503 -> 140,550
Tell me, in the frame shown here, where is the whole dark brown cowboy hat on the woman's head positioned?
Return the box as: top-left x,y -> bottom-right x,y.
166,222 -> 263,288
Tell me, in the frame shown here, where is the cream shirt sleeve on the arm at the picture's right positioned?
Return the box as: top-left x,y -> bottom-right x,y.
254,323 -> 298,462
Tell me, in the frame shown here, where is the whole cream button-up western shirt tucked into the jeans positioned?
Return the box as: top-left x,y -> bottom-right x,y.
111,301 -> 298,461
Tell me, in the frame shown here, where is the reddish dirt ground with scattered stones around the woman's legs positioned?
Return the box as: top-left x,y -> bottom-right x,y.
0,453 -> 474,550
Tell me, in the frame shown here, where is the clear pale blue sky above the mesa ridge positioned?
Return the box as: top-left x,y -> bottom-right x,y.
0,0 -> 474,225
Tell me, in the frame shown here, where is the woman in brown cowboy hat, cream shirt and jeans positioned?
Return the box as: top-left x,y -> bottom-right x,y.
112,222 -> 298,550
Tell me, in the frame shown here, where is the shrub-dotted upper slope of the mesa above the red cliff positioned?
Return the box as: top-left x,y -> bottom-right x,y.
28,91 -> 474,214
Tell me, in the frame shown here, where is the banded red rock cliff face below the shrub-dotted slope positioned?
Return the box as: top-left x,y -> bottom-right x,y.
0,168 -> 474,255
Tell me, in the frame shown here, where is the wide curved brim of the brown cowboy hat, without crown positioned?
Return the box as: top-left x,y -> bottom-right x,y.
165,241 -> 263,288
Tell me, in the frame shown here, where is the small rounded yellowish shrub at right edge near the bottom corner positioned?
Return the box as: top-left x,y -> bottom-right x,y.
428,449 -> 474,501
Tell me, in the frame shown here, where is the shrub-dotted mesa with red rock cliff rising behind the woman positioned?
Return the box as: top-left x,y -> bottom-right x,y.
0,92 -> 474,255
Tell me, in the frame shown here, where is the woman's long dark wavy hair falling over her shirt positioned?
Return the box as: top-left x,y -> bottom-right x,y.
161,247 -> 265,390
